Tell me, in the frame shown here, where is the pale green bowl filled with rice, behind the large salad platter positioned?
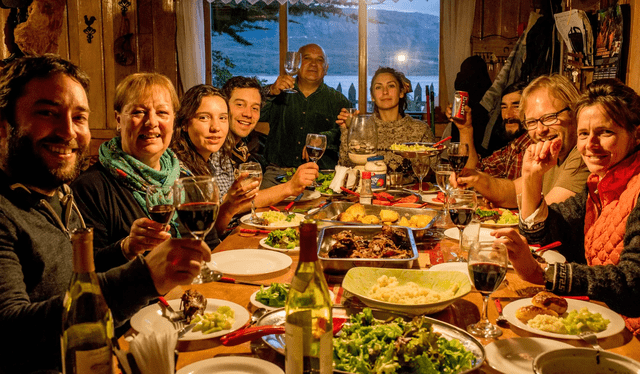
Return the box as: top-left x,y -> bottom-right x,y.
342,267 -> 471,315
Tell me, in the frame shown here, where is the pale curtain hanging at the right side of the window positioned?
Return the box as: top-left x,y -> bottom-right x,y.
438,0 -> 476,108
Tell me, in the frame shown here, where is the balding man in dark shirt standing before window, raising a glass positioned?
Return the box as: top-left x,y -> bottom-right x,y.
260,44 -> 351,188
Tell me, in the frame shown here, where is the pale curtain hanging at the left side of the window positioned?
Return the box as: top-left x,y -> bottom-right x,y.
176,0 -> 206,92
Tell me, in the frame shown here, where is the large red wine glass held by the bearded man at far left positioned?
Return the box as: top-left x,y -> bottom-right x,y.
173,176 -> 220,284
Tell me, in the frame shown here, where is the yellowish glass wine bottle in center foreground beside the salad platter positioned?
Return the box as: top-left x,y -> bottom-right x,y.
285,220 -> 333,374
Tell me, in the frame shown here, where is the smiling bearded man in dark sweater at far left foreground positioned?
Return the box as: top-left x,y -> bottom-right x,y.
0,55 -> 211,373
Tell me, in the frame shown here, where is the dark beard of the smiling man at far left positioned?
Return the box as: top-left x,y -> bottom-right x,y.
5,127 -> 88,190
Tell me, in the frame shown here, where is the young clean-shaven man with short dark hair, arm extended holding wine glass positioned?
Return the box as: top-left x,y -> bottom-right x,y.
211,76 -> 318,232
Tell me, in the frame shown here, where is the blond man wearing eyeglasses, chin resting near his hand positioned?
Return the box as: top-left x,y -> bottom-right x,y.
452,74 -> 589,207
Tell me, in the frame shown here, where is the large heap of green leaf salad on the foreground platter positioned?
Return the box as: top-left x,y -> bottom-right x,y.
333,308 -> 475,374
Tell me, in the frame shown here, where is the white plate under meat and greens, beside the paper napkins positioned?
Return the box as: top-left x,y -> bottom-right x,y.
131,299 -> 250,340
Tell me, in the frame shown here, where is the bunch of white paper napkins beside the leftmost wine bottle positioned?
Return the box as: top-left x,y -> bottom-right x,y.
129,330 -> 178,374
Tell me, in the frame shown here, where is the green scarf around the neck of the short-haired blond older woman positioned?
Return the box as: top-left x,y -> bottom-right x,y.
98,136 -> 180,238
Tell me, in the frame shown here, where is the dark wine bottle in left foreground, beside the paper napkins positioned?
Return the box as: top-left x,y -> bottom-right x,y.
60,228 -> 114,374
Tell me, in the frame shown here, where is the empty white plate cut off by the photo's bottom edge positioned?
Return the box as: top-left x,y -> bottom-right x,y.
176,356 -> 284,374
